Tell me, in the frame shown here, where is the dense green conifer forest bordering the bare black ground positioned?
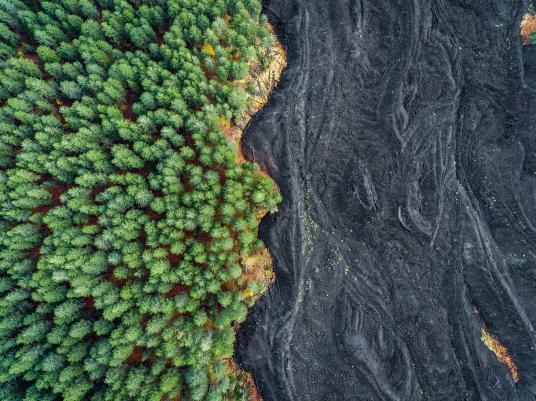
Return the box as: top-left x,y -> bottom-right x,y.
0,0 -> 280,401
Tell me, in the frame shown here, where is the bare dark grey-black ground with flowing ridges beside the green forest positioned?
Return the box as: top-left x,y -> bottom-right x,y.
236,0 -> 536,401
